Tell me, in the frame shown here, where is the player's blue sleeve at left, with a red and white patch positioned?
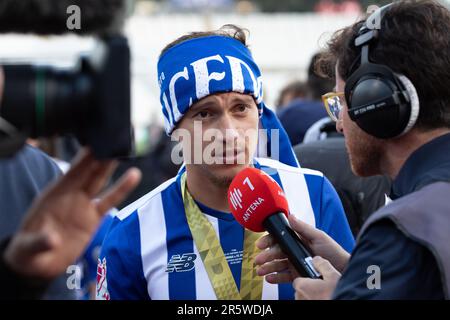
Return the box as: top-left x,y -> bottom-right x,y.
96,213 -> 149,300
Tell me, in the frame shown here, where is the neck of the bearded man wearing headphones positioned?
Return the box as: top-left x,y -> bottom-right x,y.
381,128 -> 450,179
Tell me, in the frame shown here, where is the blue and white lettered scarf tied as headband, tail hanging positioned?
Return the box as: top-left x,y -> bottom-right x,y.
158,35 -> 298,166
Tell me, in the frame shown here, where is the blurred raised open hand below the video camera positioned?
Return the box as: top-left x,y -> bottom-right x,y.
4,151 -> 141,280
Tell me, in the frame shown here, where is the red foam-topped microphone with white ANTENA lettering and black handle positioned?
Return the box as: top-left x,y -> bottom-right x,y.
228,168 -> 321,279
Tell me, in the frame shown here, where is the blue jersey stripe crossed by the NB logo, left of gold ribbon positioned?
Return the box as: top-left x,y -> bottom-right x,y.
161,175 -> 200,300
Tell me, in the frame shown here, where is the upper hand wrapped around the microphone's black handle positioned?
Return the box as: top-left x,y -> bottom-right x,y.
255,214 -> 350,283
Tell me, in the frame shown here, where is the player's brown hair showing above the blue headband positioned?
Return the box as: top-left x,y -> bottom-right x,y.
160,24 -> 248,56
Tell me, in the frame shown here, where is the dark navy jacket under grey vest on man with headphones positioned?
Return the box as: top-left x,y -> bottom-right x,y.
334,134 -> 450,299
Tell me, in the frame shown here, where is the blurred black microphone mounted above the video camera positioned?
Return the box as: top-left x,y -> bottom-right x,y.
0,0 -> 127,36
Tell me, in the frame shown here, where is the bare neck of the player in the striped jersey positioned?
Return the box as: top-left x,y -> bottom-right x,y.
186,166 -> 230,212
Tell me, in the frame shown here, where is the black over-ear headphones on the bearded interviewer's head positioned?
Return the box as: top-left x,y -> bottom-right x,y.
345,3 -> 419,139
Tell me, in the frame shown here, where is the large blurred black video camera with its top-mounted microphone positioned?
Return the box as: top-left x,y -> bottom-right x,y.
0,0 -> 133,158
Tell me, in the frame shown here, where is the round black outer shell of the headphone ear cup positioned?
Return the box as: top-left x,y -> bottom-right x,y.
346,64 -> 411,139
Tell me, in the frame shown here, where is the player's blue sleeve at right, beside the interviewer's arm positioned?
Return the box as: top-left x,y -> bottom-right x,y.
318,176 -> 355,253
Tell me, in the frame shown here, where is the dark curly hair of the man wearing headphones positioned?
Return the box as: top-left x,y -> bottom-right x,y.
316,0 -> 450,130
